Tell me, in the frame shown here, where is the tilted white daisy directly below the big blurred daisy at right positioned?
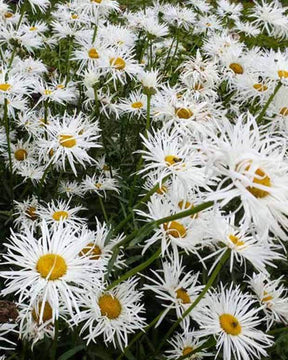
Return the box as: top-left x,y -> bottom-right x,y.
203,214 -> 284,274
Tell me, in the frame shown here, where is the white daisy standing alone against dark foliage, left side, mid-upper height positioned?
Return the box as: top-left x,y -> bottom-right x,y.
38,112 -> 100,175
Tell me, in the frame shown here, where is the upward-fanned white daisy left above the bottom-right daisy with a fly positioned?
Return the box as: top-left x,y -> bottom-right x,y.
144,253 -> 203,324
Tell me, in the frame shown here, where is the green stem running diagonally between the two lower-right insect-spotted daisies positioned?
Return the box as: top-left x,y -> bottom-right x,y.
154,249 -> 231,358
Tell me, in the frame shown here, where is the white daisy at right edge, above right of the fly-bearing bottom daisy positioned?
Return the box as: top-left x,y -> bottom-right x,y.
249,274 -> 288,329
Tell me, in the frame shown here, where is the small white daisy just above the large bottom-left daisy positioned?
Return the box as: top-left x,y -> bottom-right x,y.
38,200 -> 86,228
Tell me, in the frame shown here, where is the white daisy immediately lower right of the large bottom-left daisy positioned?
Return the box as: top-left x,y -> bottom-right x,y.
74,278 -> 145,349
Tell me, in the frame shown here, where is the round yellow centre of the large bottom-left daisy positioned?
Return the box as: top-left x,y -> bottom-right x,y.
36,254 -> 67,280
